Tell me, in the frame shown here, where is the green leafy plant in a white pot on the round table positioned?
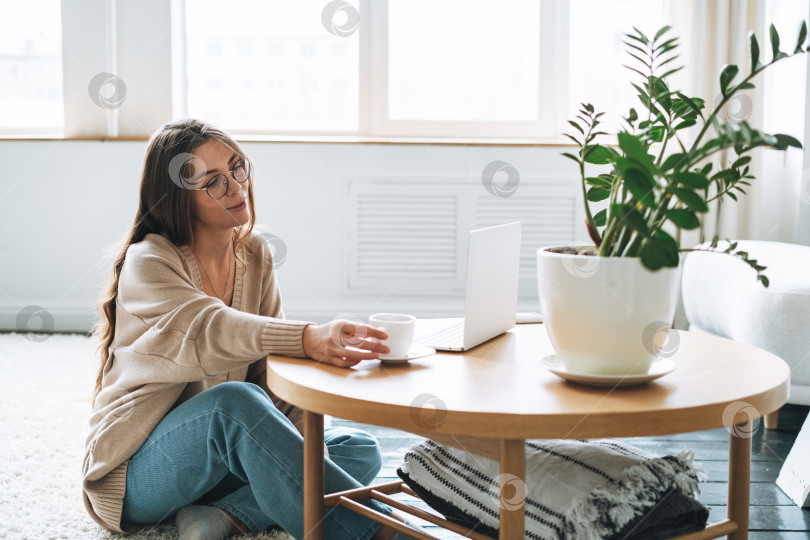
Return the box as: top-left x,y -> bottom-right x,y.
537,22 -> 810,375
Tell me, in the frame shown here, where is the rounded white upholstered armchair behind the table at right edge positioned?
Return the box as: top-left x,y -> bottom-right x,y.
681,240 -> 810,428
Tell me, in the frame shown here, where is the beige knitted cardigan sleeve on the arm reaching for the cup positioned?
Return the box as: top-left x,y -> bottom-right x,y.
116,235 -> 313,377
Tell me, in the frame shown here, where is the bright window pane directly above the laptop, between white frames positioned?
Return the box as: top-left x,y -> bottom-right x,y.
387,0 -> 540,121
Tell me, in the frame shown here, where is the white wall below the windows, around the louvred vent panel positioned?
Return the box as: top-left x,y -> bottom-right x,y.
0,140 -> 584,331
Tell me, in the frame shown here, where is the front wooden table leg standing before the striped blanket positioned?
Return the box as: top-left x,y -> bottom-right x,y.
499,439 -> 526,540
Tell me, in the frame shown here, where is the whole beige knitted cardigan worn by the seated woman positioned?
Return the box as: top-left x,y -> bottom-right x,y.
82,232 -> 315,532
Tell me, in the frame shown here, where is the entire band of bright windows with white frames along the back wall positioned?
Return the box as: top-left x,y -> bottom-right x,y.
6,0 -> 672,140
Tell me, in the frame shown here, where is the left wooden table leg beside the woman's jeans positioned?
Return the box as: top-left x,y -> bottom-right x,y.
304,411 -> 324,540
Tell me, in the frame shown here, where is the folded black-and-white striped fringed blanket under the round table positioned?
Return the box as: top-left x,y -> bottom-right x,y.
397,439 -> 709,540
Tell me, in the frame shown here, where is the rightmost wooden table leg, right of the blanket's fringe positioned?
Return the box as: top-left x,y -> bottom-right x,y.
728,420 -> 752,540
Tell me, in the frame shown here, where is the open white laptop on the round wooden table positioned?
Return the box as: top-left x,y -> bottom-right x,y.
414,221 -> 521,351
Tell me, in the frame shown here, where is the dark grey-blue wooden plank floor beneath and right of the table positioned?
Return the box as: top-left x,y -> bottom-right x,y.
331,405 -> 810,540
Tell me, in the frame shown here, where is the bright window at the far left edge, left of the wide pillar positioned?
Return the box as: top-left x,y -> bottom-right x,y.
0,0 -> 64,133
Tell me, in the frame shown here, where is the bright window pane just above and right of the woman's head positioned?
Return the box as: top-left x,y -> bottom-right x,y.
185,0 -> 359,133
